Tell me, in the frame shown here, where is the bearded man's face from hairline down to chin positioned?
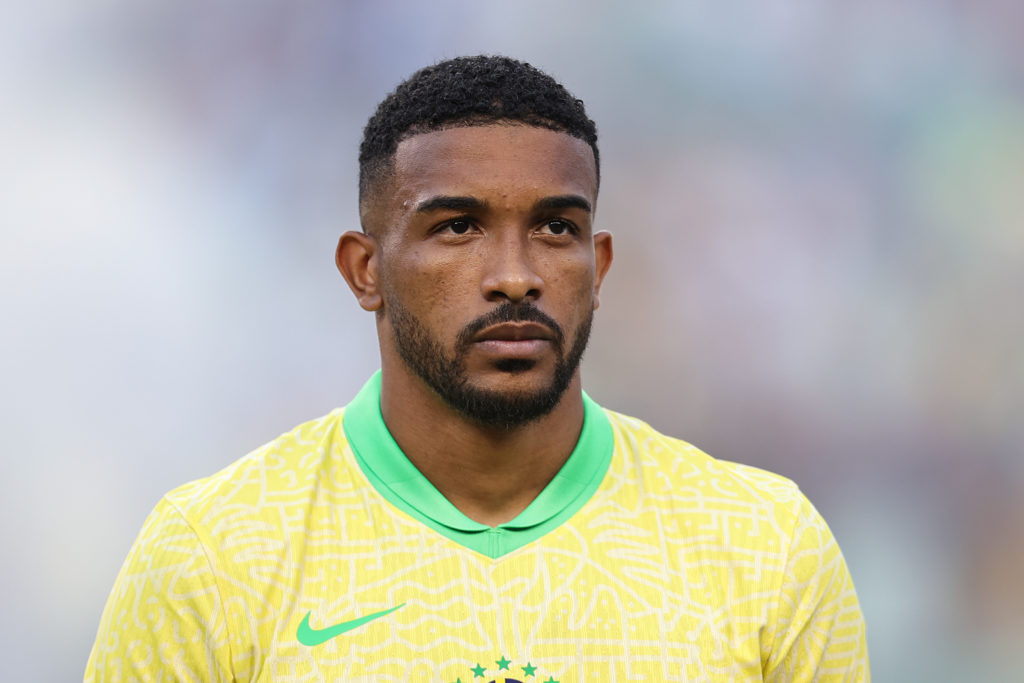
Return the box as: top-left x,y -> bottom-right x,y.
368,125 -> 611,428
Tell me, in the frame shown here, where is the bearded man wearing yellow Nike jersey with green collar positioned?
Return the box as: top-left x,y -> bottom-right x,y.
86,57 -> 869,683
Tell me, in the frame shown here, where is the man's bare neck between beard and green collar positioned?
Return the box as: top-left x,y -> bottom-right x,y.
381,366 -> 584,526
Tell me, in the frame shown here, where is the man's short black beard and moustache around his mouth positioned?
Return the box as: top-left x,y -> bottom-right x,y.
387,298 -> 594,430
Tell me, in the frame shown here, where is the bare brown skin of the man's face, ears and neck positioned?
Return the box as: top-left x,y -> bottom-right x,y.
337,124 -> 612,525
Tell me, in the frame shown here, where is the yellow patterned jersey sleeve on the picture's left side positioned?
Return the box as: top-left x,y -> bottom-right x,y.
85,499 -> 233,683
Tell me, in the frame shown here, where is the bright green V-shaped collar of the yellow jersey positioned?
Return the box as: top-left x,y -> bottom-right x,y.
343,371 -> 614,558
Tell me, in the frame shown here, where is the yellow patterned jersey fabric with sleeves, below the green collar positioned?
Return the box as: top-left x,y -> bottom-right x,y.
85,410 -> 869,683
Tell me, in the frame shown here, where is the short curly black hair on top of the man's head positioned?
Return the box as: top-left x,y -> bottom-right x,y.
359,55 -> 601,206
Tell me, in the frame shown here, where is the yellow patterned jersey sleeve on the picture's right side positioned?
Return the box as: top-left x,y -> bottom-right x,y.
762,493 -> 870,683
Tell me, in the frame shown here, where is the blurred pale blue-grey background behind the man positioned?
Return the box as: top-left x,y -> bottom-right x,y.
0,0 -> 1024,682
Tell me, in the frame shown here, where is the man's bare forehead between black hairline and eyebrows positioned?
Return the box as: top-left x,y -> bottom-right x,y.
385,124 -> 597,205
